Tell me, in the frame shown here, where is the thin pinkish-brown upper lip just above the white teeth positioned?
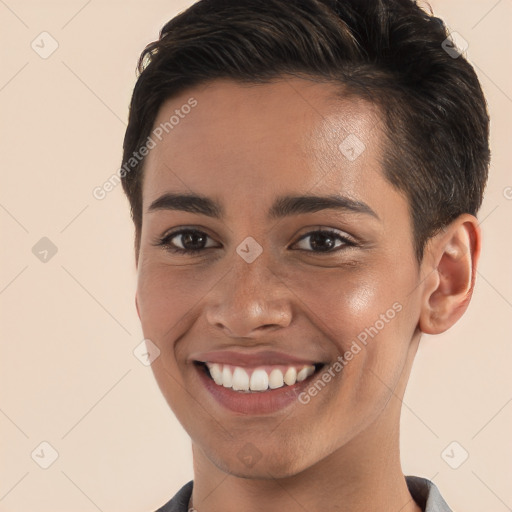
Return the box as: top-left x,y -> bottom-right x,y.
190,350 -> 321,366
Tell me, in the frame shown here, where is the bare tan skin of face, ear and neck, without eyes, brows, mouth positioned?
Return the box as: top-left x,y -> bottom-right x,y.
135,77 -> 480,512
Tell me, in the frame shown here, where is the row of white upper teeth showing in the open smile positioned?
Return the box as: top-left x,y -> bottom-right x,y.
206,363 -> 315,392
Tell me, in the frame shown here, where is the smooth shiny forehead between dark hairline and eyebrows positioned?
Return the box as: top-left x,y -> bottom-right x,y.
143,78 -> 383,216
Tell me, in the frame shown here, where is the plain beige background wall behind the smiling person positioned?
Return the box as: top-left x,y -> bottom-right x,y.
0,0 -> 512,512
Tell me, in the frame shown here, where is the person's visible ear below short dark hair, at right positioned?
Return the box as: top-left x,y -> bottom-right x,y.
419,214 -> 482,334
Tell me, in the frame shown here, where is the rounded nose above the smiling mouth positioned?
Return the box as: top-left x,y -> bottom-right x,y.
206,255 -> 292,339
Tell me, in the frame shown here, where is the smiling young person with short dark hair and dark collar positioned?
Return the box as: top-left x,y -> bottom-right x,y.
121,0 -> 489,512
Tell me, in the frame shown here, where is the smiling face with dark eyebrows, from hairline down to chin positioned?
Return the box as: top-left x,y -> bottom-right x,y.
136,78 -> 421,477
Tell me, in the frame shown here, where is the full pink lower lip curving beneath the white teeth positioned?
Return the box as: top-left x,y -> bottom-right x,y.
195,366 -> 317,414
